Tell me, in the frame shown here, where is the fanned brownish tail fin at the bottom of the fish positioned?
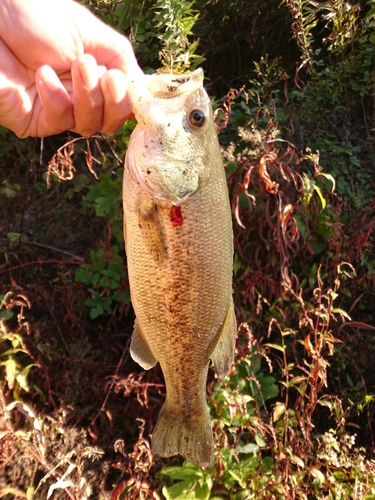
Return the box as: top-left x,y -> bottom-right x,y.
152,403 -> 214,469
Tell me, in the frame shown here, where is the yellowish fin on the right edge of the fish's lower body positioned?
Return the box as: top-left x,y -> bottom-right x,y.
211,299 -> 237,379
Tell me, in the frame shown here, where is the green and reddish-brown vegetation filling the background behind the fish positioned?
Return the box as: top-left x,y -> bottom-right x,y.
0,0 -> 375,500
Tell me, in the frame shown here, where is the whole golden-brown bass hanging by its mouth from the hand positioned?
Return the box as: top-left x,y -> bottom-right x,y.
123,68 -> 237,469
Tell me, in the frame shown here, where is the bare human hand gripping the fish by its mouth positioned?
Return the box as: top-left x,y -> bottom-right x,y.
0,0 -> 141,137
